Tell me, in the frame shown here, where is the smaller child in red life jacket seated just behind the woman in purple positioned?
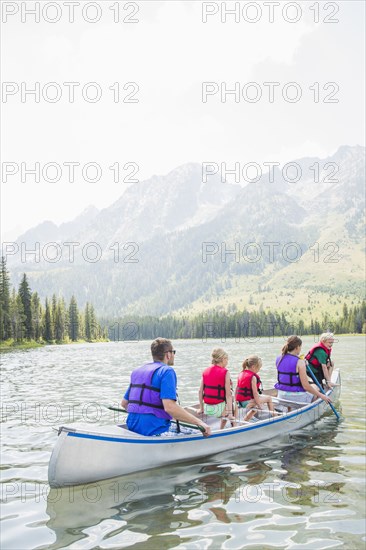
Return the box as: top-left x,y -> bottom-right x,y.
235,355 -> 274,421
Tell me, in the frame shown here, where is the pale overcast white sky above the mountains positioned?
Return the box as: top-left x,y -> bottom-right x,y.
1,0 -> 365,240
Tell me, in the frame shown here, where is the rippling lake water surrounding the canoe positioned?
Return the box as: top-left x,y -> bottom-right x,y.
1,336 -> 365,550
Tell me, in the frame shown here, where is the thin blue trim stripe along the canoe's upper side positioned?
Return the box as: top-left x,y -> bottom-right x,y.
67,402 -> 321,445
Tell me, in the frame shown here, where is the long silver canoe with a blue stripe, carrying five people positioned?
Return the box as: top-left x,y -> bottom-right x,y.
48,370 -> 341,487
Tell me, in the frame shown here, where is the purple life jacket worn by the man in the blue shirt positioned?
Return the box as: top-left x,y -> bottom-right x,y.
127,363 -> 172,420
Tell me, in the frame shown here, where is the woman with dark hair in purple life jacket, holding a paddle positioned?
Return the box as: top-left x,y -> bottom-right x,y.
275,336 -> 331,403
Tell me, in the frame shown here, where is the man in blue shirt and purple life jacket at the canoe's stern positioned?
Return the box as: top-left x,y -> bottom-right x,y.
122,338 -> 211,437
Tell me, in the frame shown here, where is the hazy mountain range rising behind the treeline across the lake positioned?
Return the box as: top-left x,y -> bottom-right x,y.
5,146 -> 365,319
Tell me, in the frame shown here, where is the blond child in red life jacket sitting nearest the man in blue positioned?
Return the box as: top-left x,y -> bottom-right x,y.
198,348 -> 234,430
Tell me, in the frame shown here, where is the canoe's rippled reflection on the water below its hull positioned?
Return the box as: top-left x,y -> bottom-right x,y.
47,417 -> 339,549
